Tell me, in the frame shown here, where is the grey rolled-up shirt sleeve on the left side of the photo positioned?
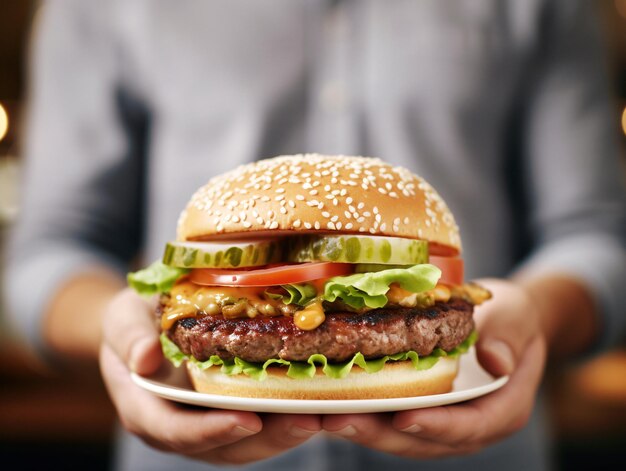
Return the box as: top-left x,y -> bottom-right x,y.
5,0 -> 142,360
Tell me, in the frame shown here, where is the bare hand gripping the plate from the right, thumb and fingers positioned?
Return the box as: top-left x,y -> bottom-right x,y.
322,280 -> 546,458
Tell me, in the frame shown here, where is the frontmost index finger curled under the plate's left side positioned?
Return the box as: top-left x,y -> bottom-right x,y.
100,345 -> 262,455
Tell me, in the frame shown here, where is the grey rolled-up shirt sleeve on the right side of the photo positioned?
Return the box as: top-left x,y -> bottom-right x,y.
522,0 -> 626,349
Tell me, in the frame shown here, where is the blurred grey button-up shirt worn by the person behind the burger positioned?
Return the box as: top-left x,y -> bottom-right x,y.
7,0 -> 626,470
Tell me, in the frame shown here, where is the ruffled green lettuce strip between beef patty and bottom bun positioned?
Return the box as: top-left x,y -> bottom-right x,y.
161,331 -> 478,381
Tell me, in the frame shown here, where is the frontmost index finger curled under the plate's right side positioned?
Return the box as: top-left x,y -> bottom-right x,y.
393,338 -> 545,447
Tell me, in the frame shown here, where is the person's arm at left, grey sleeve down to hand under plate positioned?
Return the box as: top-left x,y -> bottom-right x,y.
7,0 -> 320,463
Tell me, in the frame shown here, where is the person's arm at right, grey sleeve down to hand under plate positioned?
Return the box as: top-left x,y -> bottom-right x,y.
322,2 -> 626,458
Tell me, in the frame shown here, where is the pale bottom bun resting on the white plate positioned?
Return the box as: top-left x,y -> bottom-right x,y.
187,357 -> 459,399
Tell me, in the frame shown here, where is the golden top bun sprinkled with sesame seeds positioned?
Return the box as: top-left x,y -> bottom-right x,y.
178,154 -> 461,254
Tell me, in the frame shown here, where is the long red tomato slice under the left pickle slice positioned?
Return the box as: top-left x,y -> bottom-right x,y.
190,262 -> 354,286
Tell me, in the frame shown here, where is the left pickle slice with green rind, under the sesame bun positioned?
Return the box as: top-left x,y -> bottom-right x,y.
163,240 -> 280,268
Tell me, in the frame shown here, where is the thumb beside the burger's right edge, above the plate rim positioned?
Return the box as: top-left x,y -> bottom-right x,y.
476,280 -> 538,376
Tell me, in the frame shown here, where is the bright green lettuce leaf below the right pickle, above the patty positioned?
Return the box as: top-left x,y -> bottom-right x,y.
324,264 -> 441,309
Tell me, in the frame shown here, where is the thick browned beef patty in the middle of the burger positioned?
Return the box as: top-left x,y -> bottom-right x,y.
167,298 -> 474,362
